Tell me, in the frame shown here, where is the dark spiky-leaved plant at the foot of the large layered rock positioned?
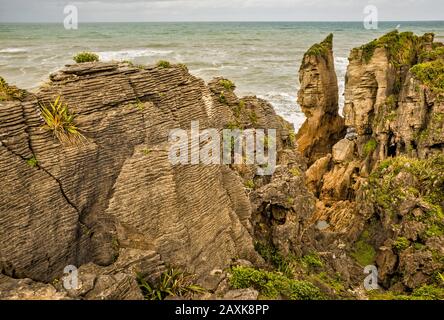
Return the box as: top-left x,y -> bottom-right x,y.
137,268 -> 205,300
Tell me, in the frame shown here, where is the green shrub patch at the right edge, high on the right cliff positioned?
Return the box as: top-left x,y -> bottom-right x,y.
410,59 -> 444,94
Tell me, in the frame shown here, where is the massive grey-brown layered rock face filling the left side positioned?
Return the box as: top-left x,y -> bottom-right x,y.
0,63 -> 308,299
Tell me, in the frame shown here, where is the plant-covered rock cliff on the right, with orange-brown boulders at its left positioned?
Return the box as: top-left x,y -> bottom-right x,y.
300,31 -> 444,294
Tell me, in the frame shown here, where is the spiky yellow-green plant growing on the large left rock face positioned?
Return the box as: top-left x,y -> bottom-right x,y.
40,96 -> 86,144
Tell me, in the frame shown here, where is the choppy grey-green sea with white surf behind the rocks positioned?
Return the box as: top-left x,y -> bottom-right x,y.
0,21 -> 444,129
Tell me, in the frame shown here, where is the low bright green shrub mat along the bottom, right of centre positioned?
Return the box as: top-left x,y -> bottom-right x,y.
230,266 -> 324,300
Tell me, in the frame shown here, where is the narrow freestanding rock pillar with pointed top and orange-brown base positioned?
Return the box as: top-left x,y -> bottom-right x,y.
297,34 -> 345,164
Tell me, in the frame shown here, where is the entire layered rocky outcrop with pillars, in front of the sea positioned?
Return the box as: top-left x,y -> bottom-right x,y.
0,32 -> 444,299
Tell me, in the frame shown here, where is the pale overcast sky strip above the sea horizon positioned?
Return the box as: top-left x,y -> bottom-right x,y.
0,0 -> 444,22
